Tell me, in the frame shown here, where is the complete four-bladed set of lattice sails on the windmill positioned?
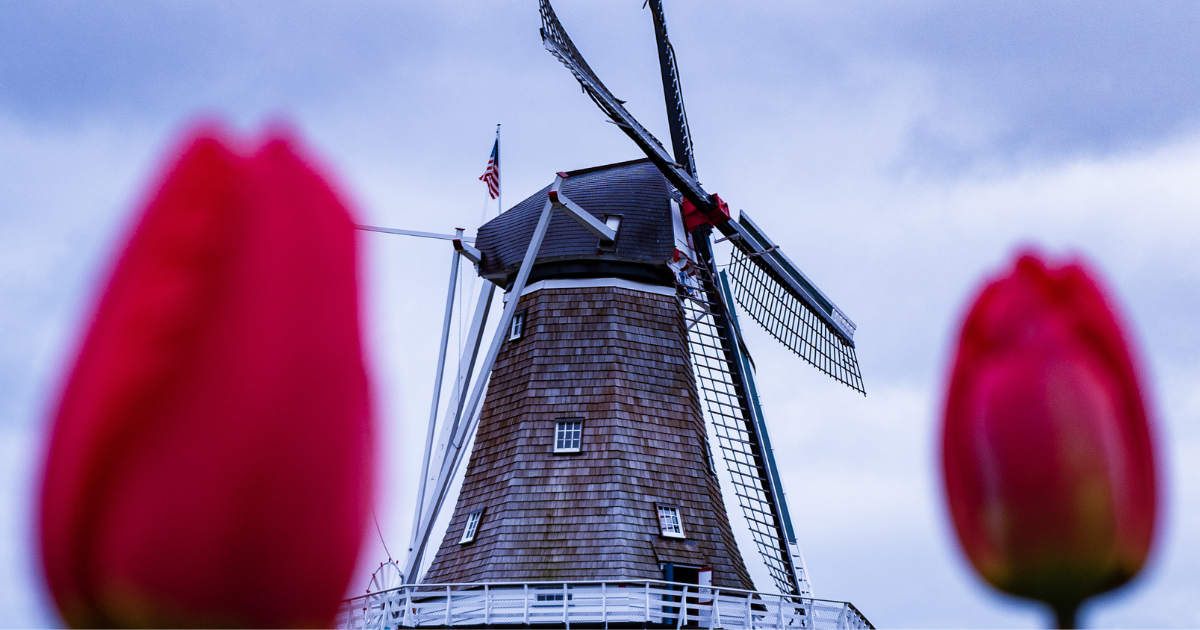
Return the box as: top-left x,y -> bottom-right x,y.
539,0 -> 862,594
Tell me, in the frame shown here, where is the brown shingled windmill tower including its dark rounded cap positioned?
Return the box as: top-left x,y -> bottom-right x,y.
425,160 -> 751,588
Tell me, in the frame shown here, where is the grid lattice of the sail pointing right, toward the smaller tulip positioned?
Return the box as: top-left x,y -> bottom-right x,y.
730,247 -> 866,395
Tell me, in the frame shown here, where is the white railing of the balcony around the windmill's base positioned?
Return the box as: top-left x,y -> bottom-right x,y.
336,581 -> 874,630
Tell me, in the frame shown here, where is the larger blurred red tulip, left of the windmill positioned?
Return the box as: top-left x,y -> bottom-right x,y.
41,129 -> 372,628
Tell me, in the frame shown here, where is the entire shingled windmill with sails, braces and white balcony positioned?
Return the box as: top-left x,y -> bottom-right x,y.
342,0 -> 870,628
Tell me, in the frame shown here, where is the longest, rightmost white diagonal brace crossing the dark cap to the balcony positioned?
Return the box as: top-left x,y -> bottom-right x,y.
404,175 -> 563,576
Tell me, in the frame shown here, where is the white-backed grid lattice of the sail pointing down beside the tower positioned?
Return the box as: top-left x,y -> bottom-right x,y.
678,265 -> 797,594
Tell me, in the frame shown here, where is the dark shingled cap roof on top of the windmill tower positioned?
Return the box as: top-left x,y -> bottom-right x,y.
475,160 -> 674,286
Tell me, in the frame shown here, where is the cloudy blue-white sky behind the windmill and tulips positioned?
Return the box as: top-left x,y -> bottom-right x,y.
0,0 -> 1200,628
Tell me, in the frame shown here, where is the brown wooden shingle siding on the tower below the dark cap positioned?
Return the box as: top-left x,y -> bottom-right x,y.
426,287 -> 752,589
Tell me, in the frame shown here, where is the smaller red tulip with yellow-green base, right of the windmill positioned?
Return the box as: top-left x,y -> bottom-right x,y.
942,254 -> 1156,625
